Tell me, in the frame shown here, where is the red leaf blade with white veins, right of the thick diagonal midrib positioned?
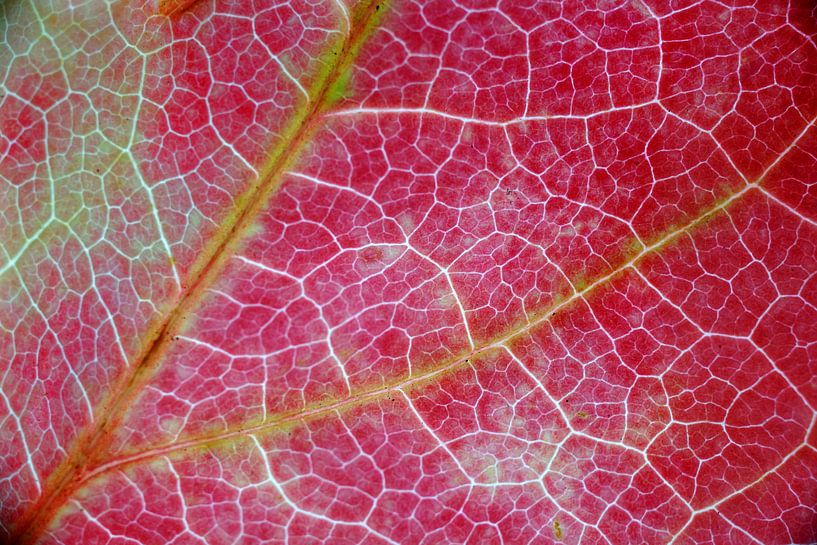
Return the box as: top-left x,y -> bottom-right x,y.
1,3 -> 815,543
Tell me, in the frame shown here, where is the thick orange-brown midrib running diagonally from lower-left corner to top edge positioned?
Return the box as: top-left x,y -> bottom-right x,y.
5,0 -> 387,545
